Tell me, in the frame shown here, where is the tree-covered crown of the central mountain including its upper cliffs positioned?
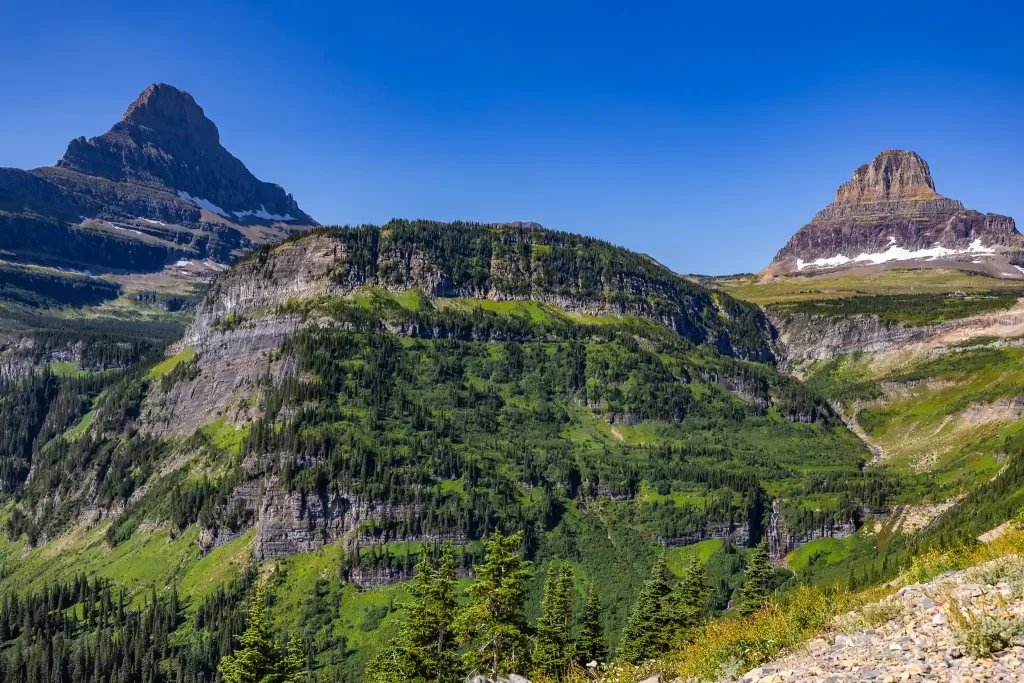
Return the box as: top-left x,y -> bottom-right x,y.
216,220 -> 773,361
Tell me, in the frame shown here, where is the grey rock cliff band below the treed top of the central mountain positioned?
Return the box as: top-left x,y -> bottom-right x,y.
185,225 -> 775,361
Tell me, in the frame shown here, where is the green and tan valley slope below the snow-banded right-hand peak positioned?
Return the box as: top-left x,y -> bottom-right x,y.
719,268 -> 1024,583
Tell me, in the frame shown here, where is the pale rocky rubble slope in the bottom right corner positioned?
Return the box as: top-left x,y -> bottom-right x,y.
738,556 -> 1024,683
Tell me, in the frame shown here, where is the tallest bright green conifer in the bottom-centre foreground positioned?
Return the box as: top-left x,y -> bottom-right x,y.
456,531 -> 529,678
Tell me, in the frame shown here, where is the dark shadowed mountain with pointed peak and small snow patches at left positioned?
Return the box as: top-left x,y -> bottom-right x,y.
0,84 -> 317,271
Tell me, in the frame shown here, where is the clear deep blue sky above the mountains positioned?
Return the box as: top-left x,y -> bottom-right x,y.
0,0 -> 1024,273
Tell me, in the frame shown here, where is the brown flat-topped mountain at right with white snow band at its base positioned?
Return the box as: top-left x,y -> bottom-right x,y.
766,150 -> 1024,279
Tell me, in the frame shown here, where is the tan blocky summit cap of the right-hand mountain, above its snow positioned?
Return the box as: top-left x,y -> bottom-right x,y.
836,150 -> 940,204
